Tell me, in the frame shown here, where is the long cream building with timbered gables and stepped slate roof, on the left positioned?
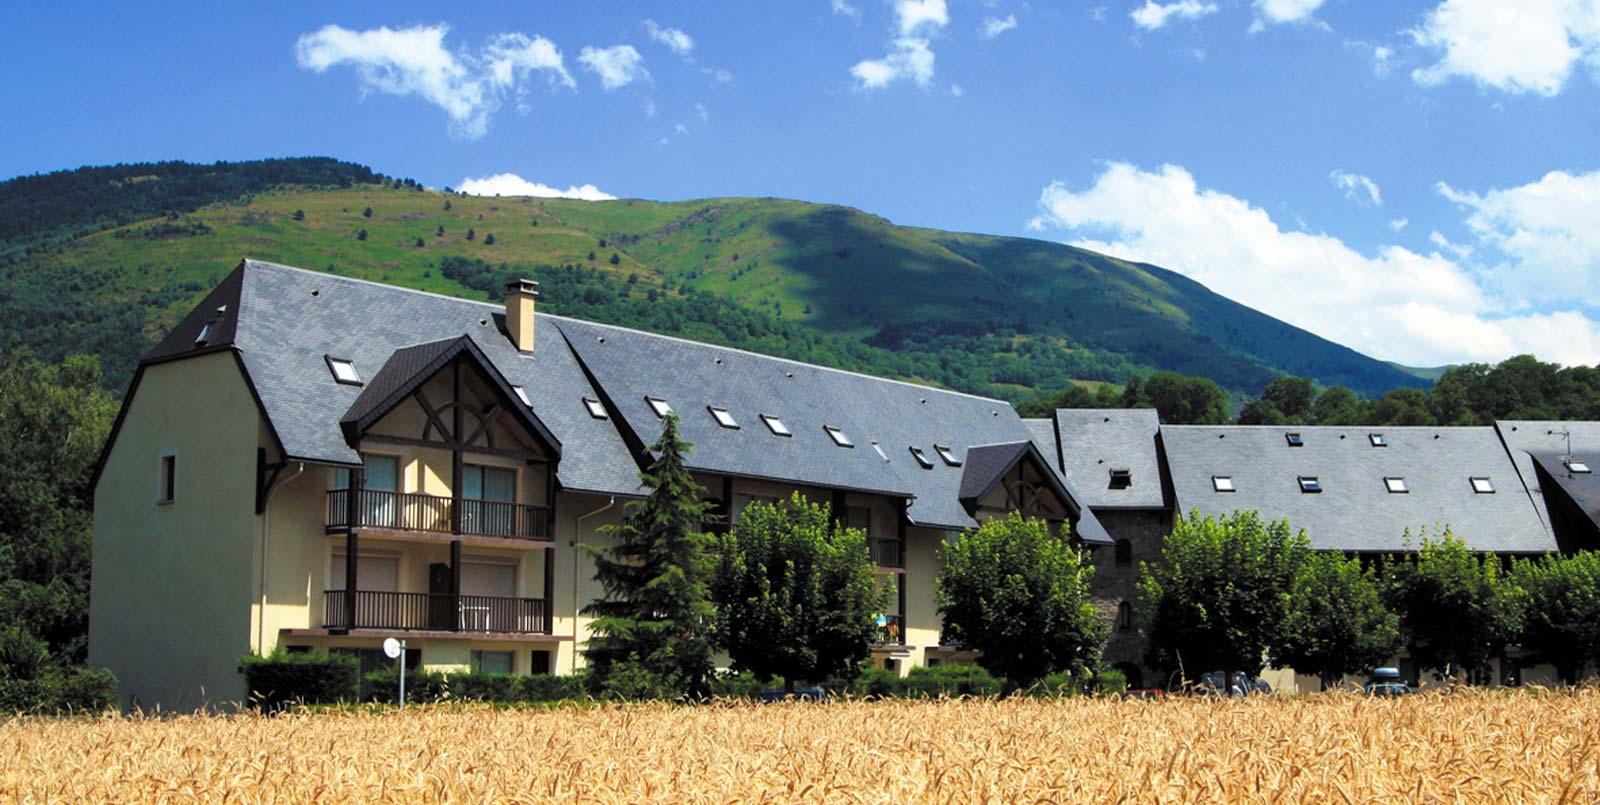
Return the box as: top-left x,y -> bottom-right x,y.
90,261 -> 1110,709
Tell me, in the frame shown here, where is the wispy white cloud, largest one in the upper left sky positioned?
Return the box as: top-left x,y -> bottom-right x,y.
294,26 -> 576,138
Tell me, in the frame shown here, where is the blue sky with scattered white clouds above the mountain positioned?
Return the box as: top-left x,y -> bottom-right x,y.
0,0 -> 1600,365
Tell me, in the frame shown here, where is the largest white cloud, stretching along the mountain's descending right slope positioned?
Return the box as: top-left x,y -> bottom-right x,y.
1029,163 -> 1600,365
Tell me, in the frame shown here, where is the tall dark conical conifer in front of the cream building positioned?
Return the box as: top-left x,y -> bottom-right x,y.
584,413 -> 717,698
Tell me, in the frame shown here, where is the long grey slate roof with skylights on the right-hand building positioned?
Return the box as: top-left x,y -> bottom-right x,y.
1162,426 -> 1555,554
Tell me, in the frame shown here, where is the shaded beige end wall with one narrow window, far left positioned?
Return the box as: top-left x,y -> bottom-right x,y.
90,352 -> 259,709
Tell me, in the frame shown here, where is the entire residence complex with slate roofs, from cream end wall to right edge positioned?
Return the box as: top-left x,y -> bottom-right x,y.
90,261 -> 1600,709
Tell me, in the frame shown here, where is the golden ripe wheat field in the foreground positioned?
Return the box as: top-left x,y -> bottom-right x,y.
0,690 -> 1600,803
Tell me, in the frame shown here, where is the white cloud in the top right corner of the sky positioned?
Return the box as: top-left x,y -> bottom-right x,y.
1410,0 -> 1600,96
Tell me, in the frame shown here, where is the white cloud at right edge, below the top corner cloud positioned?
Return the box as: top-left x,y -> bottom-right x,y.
1438,171 -> 1600,307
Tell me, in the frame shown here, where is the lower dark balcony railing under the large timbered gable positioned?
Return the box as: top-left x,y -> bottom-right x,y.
322,591 -> 550,634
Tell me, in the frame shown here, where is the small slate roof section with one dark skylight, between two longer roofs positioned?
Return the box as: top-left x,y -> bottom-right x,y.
1054,408 -> 1170,509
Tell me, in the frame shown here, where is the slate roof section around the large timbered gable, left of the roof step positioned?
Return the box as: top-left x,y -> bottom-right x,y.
222,261 -> 640,495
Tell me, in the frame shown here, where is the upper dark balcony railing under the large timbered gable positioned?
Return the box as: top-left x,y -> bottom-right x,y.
328,490 -> 550,539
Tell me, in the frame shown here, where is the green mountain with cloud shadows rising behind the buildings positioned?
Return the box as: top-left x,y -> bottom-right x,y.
0,158 -> 1427,398
